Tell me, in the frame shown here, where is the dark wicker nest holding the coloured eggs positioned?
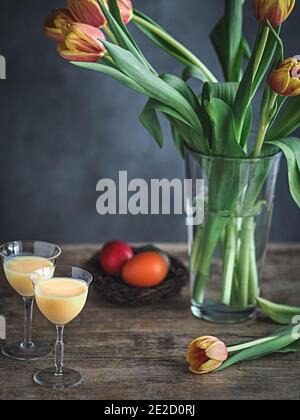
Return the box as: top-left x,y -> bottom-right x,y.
85,252 -> 189,306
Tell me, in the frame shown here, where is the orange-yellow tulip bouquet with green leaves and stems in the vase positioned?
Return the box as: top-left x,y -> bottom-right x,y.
46,0 -> 300,322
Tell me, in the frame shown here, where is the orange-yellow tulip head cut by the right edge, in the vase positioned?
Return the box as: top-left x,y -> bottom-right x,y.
269,56 -> 300,96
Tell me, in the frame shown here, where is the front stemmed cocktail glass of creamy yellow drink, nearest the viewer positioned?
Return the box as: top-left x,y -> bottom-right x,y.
32,266 -> 93,390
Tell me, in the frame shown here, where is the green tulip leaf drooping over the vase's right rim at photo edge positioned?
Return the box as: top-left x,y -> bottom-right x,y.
267,137 -> 300,207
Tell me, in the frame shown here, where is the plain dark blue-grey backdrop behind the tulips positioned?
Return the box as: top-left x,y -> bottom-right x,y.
0,0 -> 300,242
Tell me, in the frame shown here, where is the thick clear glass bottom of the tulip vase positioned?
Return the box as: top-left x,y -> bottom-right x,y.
191,301 -> 257,324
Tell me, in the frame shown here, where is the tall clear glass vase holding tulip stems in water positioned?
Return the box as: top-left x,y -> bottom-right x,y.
186,150 -> 281,324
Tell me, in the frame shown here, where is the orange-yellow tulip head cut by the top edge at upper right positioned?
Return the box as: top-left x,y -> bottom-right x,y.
254,0 -> 296,28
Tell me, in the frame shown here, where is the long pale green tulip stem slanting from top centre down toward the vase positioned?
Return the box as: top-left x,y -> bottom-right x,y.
133,14 -> 218,83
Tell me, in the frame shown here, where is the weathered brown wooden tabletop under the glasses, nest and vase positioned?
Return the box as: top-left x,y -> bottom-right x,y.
0,245 -> 300,400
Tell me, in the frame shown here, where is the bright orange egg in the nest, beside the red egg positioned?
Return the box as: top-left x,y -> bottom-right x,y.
122,252 -> 169,288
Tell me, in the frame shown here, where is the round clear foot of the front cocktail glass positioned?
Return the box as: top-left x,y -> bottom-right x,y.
34,368 -> 83,391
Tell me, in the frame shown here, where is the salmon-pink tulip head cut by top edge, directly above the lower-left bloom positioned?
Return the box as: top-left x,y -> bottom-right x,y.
68,0 -> 107,28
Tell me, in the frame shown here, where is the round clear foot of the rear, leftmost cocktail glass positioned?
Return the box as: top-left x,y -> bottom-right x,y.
2,341 -> 53,361
